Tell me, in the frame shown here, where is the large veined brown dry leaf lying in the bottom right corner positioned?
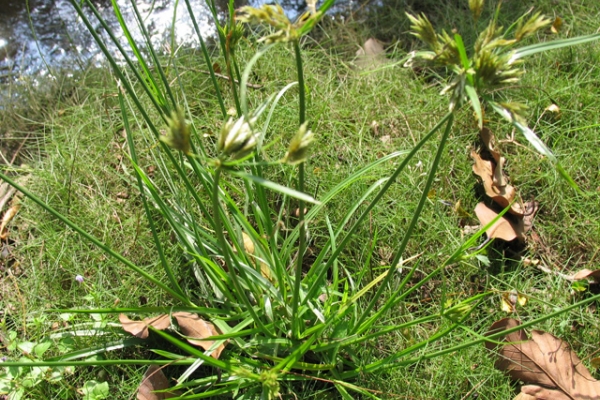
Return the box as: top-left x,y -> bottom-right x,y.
486,318 -> 600,400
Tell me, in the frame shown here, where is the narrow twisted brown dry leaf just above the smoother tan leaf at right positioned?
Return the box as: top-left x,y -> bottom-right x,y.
471,150 -> 523,216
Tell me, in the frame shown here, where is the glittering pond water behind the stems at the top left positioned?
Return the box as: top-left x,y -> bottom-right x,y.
0,0 -> 346,81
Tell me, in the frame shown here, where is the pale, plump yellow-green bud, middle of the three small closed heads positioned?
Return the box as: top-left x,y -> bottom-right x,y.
217,115 -> 256,160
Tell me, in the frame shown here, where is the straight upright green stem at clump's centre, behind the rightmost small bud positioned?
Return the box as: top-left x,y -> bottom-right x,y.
292,40 -> 306,338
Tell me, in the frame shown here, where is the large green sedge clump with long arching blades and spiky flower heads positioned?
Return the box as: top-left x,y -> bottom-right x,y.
0,0 -> 600,399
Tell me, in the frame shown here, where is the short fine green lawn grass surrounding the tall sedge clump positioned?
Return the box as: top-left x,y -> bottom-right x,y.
1,1 -> 600,399
